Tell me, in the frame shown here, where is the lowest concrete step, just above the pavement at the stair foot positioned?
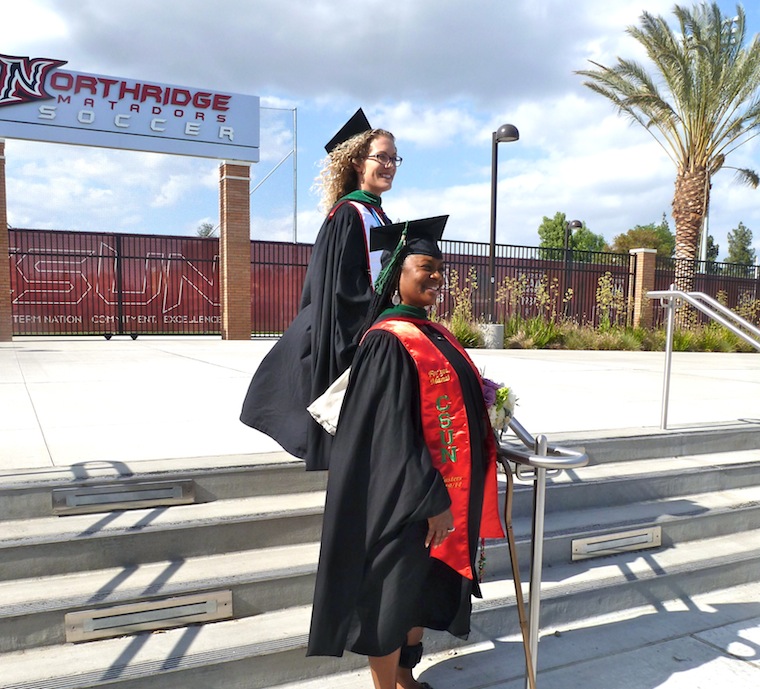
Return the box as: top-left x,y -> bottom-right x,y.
2,530 -> 760,689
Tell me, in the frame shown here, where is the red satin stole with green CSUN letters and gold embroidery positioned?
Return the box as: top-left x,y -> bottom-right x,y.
372,318 -> 504,579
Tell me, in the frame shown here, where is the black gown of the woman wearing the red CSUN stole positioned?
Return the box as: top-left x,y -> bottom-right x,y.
308,312 -> 488,656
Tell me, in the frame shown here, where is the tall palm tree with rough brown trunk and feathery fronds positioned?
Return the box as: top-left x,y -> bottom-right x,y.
577,2 -> 760,291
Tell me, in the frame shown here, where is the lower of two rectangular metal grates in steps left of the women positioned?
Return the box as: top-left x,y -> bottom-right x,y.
64,591 -> 232,642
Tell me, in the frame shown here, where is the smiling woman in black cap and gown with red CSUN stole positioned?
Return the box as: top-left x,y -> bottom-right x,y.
308,216 -> 503,689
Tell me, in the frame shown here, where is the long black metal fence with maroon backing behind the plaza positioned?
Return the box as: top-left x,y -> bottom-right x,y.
9,229 -> 760,337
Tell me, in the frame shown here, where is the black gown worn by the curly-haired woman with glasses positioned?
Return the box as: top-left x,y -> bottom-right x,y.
240,202 -> 382,470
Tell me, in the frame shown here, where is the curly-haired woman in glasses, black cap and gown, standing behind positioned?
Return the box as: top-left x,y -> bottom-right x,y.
240,109 -> 401,470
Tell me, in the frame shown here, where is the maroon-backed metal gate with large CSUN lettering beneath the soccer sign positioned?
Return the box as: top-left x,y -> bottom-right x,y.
9,229 -> 221,337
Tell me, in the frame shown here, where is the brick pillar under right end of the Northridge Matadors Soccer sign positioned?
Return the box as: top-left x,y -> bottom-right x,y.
219,161 -> 251,340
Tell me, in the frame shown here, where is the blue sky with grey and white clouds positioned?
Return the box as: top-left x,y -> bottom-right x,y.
0,0 -> 760,256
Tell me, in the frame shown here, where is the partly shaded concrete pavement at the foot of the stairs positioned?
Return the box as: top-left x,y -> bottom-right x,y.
278,583 -> 760,689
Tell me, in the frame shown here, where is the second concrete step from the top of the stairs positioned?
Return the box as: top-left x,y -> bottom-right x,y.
0,451 -> 760,581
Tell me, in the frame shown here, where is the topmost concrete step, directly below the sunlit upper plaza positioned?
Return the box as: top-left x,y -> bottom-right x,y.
0,423 -> 760,521
